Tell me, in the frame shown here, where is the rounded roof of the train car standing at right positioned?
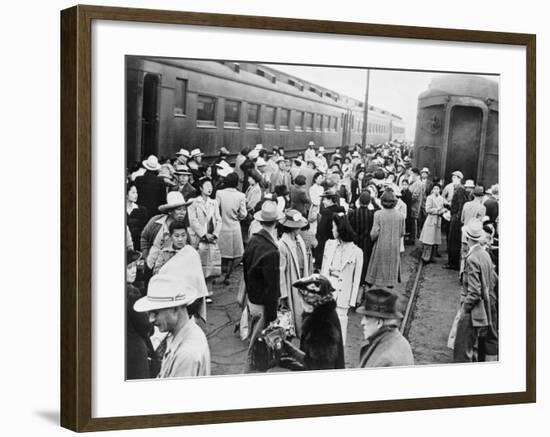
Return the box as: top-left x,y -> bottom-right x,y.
418,74 -> 498,102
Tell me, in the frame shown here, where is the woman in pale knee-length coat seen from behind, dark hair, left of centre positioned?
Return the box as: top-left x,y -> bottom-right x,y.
216,173 -> 246,285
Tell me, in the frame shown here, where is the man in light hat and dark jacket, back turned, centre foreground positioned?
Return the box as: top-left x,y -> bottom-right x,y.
243,201 -> 283,373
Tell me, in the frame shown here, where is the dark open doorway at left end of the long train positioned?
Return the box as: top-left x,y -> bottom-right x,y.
141,73 -> 160,159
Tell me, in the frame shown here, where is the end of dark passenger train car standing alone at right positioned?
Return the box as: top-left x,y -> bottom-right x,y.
414,75 -> 499,187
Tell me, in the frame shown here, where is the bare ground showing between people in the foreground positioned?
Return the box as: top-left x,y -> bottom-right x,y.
206,238 -> 460,375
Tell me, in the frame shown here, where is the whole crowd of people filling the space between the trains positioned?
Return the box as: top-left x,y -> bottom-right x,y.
126,141 -> 498,379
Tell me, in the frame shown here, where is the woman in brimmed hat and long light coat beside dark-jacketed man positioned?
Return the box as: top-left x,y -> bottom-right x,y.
277,209 -> 313,338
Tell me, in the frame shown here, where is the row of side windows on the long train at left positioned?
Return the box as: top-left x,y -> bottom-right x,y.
197,95 -> 338,132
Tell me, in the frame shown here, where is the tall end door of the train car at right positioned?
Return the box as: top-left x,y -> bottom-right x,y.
445,106 -> 483,181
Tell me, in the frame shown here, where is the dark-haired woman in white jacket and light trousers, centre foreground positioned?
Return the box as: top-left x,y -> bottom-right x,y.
321,213 -> 363,345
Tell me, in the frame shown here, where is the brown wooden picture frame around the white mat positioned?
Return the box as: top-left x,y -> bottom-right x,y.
61,6 -> 536,432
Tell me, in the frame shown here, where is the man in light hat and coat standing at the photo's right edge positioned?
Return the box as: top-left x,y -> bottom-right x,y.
453,219 -> 498,363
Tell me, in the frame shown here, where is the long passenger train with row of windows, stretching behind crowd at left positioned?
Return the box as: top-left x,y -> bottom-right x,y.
126,56 -> 404,163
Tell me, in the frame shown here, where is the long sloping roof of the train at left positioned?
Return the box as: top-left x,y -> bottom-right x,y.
141,57 -> 402,120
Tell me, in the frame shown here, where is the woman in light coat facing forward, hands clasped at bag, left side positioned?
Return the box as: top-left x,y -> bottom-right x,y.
187,177 -> 222,303
